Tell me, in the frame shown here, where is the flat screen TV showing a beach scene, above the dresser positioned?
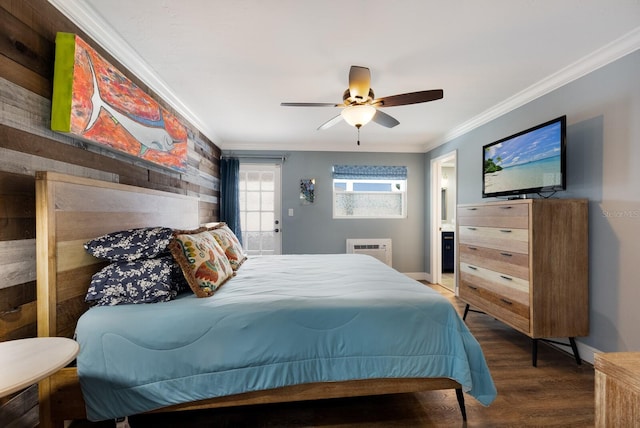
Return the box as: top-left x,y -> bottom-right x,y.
482,116 -> 567,198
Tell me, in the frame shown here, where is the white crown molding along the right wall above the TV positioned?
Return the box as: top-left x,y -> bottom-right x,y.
423,27 -> 640,152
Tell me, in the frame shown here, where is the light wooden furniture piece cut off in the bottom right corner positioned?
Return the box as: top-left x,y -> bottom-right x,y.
595,352 -> 640,428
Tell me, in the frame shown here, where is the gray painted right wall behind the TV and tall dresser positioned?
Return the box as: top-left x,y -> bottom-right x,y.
424,51 -> 640,352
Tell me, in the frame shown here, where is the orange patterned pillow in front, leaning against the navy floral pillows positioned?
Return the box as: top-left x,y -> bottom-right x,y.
169,229 -> 234,297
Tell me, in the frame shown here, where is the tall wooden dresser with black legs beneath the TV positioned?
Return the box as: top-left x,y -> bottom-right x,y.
457,199 -> 589,366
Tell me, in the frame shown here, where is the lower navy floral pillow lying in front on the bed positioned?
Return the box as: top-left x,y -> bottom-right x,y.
85,255 -> 180,306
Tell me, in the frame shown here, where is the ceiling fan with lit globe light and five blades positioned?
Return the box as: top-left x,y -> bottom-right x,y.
280,65 -> 444,144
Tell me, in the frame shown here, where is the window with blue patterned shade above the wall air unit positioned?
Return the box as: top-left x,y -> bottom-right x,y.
333,165 -> 407,218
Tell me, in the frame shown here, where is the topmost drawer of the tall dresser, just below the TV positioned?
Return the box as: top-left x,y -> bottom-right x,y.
457,203 -> 529,229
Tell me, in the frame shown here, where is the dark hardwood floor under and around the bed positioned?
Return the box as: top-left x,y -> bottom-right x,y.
72,284 -> 594,428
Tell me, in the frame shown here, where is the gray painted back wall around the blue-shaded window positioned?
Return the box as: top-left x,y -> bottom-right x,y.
282,151 -> 425,273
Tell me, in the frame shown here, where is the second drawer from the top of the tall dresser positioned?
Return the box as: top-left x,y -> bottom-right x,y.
458,225 -> 529,254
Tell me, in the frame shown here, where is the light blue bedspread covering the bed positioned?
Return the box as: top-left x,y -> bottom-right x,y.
76,254 -> 496,421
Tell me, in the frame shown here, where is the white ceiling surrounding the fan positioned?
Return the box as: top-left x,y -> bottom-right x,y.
49,0 -> 640,153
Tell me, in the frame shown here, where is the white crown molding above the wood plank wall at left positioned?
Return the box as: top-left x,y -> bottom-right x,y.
48,0 -> 219,145
